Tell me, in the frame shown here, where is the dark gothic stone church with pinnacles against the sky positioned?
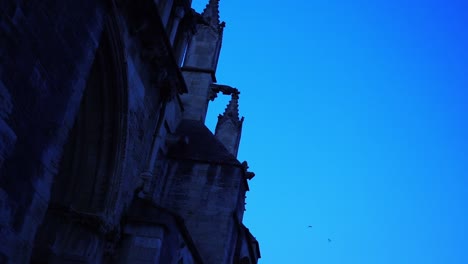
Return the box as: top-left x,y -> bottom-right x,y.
0,0 -> 260,264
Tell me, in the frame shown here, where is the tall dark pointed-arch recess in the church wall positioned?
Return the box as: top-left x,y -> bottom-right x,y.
51,11 -> 127,221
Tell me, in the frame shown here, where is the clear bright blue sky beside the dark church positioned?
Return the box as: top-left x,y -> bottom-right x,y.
193,0 -> 468,264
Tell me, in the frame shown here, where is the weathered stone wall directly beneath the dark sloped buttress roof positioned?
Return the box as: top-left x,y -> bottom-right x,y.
161,158 -> 245,263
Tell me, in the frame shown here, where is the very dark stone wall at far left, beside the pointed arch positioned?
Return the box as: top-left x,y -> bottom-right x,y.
0,0 -> 105,262
